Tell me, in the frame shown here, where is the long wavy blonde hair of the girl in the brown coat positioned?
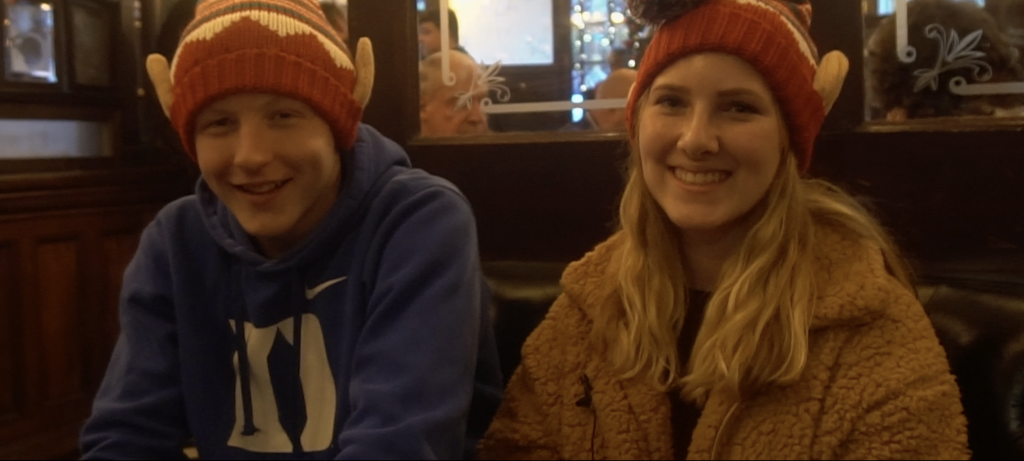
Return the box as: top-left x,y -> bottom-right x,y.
592,90 -> 911,405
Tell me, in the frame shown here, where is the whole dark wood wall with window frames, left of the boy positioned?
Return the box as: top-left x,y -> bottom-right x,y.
0,0 -> 198,459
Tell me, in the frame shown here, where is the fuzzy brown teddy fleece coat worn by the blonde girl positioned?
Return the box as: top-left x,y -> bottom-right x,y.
479,229 -> 970,459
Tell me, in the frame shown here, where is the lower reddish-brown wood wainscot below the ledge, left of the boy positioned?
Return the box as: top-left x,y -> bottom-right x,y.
0,206 -> 172,459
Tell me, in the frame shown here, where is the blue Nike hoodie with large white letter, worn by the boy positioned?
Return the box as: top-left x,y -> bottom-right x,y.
82,125 -> 502,459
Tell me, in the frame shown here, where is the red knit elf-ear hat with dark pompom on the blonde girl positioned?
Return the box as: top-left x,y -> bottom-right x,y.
627,0 -> 849,171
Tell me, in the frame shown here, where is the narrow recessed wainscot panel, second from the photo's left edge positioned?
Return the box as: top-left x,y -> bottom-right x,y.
37,240 -> 84,405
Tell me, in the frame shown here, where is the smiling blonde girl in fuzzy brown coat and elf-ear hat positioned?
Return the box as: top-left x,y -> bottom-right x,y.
480,0 -> 970,459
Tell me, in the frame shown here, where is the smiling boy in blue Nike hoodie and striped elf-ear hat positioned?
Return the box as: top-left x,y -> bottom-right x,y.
82,0 -> 501,459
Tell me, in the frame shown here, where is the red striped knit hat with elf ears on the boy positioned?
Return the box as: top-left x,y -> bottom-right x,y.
140,0 -> 374,160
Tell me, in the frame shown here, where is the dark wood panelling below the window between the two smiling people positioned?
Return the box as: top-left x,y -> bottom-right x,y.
409,133 -> 627,261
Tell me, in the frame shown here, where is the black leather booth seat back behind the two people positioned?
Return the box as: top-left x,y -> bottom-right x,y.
483,260 -> 1024,459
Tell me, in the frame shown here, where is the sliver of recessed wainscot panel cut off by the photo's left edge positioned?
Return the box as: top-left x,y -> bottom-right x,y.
0,241 -> 14,421
